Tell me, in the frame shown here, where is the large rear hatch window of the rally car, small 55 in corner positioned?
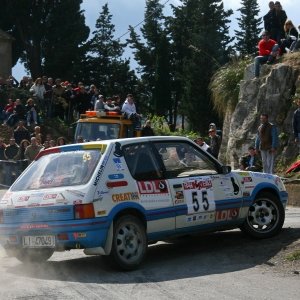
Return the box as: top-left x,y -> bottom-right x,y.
11,150 -> 101,191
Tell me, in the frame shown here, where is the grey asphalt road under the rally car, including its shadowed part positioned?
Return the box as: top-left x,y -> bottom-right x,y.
0,191 -> 300,300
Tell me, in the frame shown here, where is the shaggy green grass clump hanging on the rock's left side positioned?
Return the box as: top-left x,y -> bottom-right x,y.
209,57 -> 251,117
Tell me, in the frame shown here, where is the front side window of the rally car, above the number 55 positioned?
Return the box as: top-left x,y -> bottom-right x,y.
154,142 -> 218,178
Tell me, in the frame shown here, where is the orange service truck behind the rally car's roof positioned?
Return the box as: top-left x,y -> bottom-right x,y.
74,111 -> 141,142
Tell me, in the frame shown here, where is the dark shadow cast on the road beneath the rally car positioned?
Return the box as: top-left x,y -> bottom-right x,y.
6,228 -> 300,284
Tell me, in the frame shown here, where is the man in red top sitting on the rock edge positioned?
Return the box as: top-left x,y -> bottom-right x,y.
254,31 -> 279,77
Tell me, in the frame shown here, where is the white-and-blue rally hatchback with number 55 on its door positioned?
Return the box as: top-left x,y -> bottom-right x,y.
0,136 -> 288,270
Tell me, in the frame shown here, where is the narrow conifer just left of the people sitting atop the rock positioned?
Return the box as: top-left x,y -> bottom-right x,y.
235,0 -> 262,56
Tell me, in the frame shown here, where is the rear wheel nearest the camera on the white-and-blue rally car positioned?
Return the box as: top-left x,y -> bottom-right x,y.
108,215 -> 147,270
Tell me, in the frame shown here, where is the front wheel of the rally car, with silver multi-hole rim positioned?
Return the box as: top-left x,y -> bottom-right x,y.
241,192 -> 285,239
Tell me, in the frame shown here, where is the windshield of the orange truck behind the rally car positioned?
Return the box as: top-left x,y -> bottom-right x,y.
75,122 -> 120,142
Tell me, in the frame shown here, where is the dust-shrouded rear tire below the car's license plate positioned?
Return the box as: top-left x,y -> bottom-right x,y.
7,248 -> 54,263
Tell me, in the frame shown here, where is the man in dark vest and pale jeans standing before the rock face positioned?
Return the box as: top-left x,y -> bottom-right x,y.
255,114 -> 278,174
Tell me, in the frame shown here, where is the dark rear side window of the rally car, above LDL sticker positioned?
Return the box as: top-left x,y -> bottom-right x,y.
122,143 -> 162,180
